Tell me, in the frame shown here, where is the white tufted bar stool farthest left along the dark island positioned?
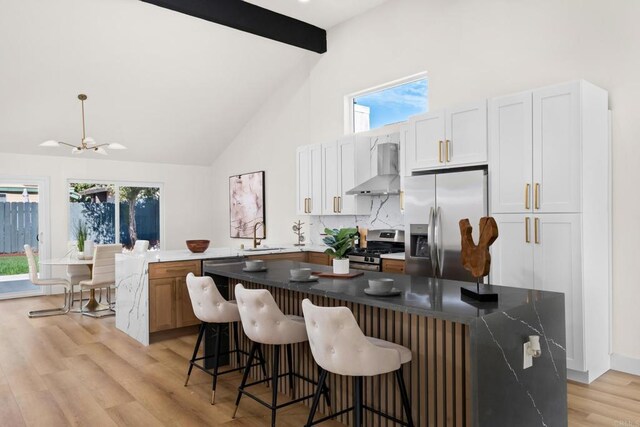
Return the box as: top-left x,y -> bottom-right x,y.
184,273 -> 267,405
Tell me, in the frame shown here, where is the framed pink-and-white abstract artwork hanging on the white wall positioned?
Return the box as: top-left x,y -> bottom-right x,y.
229,171 -> 266,239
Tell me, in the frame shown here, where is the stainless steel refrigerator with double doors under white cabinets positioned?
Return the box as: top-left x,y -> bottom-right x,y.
404,167 -> 488,282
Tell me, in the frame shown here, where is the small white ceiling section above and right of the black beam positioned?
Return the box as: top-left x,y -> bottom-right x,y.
245,0 -> 387,29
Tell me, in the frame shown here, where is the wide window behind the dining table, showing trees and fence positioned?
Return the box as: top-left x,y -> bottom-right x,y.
69,181 -> 161,249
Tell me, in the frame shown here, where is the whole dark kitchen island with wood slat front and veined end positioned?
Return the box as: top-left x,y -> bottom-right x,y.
204,261 -> 567,426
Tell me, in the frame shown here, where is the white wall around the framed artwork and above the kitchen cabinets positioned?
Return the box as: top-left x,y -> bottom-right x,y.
213,0 -> 640,360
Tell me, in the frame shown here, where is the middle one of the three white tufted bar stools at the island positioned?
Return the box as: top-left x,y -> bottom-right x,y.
233,284 -> 330,427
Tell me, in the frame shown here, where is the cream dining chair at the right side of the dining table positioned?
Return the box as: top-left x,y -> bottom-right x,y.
80,244 -> 122,317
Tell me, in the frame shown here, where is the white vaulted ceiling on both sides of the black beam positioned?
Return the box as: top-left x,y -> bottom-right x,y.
0,0 -> 384,165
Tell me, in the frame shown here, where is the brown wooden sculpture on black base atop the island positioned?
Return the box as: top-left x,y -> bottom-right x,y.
459,216 -> 498,301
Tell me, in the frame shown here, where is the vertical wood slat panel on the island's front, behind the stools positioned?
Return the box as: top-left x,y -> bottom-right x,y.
232,280 -> 471,426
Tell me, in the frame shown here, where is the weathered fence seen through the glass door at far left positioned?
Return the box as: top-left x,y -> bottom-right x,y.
0,202 -> 38,254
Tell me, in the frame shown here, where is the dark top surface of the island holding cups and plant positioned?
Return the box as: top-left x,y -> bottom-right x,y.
204,261 -> 562,324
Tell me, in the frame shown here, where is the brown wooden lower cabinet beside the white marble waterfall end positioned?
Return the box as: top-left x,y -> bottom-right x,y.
149,261 -> 202,332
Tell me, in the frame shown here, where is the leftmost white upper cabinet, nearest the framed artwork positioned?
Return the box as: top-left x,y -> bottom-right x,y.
296,144 -> 322,215
